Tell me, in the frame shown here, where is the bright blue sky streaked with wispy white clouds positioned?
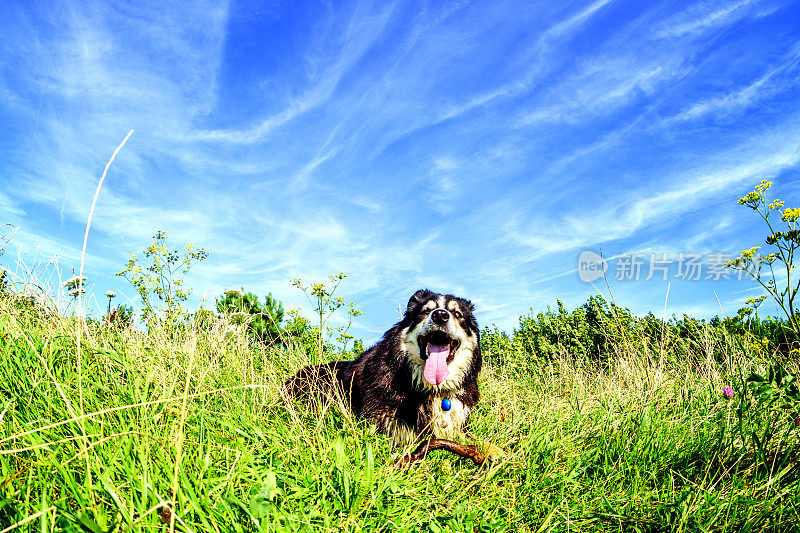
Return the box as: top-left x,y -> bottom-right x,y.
0,0 -> 800,341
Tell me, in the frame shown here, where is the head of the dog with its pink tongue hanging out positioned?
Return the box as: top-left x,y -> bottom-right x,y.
401,290 -> 481,391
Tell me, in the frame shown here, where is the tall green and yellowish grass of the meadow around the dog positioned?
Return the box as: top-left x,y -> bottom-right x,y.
0,296 -> 800,532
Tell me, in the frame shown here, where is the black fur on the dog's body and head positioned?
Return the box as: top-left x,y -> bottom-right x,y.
284,290 -> 482,435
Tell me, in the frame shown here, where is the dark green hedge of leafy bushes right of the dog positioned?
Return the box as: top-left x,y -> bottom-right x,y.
481,295 -> 798,366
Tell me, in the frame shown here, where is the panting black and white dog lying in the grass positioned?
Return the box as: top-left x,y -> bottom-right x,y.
283,289 -> 483,444
